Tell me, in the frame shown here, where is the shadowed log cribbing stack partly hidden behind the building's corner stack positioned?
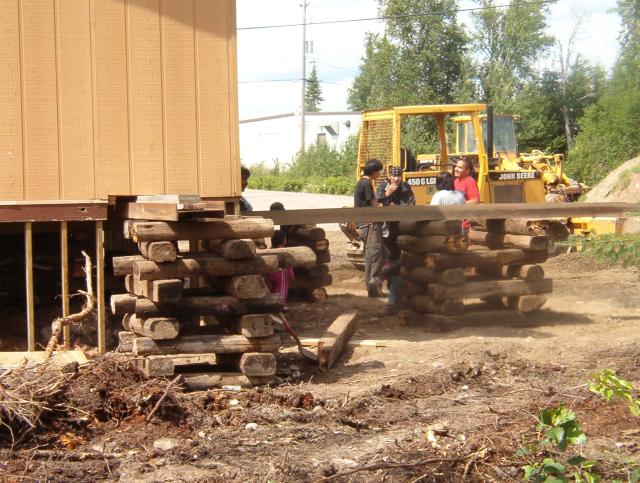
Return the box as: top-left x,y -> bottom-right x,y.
282,225 -> 333,302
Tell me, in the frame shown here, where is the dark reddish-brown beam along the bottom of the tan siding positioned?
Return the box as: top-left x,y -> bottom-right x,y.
0,200 -> 107,223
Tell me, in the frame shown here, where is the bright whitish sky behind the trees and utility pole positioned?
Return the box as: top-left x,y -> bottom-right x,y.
236,0 -> 620,120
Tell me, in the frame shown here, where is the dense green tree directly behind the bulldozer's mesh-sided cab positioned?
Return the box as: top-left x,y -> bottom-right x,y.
348,0 -> 468,110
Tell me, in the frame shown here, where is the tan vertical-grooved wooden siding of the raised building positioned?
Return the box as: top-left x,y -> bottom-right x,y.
0,0 -> 240,200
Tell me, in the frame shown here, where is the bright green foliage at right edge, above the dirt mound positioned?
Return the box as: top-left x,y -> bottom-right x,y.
567,0 -> 640,184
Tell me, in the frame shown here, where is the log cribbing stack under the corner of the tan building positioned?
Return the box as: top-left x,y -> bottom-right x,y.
111,216 -> 316,388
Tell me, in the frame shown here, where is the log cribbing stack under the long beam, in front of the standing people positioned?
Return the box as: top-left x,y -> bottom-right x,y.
398,220 -> 552,326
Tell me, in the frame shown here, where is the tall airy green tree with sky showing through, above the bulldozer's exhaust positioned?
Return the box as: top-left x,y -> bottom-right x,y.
472,0 -> 553,112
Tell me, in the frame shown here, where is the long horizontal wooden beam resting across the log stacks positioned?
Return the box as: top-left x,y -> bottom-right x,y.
251,203 -> 640,225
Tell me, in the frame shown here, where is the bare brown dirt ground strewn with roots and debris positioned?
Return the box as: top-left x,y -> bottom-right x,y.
0,232 -> 640,482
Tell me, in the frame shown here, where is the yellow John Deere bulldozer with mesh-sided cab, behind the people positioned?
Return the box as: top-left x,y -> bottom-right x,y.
356,104 -> 545,204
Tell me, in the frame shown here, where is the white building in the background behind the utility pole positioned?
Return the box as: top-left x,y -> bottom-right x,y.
240,112 -> 360,166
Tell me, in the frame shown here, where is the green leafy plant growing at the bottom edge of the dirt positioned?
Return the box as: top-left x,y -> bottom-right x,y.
516,406 -> 600,483
